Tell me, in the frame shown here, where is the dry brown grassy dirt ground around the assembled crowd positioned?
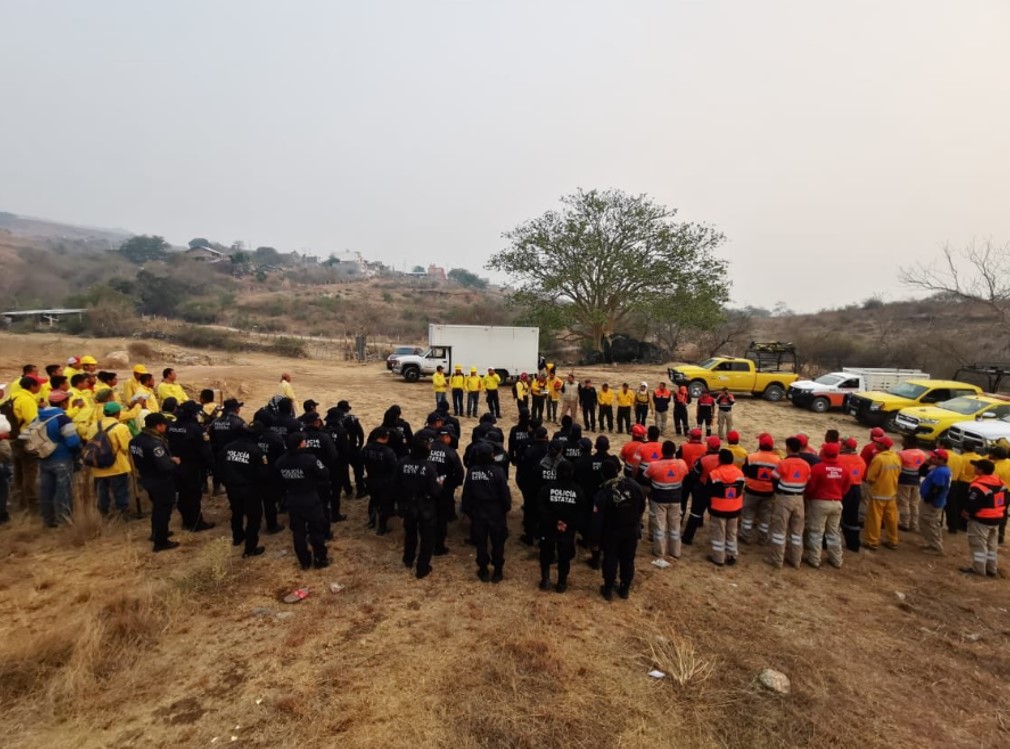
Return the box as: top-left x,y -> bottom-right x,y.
0,335 -> 1010,749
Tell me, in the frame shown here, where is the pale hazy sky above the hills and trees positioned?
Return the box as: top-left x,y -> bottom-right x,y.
0,0 -> 1010,311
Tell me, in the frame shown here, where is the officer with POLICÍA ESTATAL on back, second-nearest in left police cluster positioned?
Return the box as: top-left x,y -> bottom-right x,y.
217,429 -> 270,557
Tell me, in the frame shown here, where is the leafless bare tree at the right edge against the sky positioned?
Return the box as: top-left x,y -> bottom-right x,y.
898,239 -> 1010,321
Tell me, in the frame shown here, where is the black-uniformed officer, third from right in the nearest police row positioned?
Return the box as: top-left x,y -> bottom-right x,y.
463,442 -> 512,582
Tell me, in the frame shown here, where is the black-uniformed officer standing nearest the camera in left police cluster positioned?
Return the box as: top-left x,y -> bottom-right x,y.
277,432 -> 329,569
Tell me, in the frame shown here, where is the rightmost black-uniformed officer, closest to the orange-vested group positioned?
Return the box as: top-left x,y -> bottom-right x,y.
593,457 -> 645,601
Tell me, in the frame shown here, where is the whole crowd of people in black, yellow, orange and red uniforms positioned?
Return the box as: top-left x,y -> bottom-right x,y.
0,356 -> 1010,600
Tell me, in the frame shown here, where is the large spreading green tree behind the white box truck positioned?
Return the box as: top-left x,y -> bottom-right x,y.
487,190 -> 729,350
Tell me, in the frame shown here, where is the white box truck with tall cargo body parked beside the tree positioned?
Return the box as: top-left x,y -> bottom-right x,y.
393,324 -> 540,383
